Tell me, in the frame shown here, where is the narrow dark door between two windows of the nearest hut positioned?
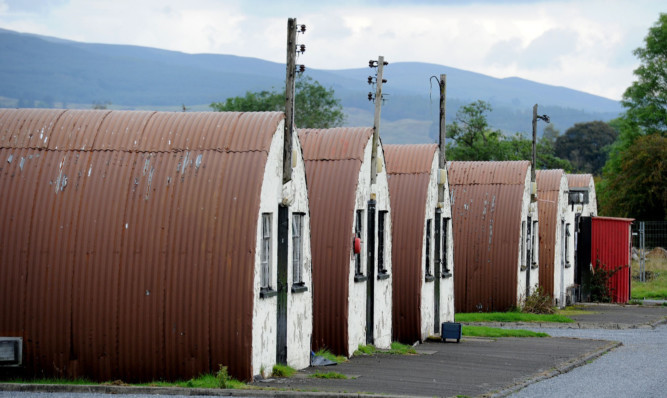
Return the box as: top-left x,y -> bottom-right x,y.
276,206 -> 289,365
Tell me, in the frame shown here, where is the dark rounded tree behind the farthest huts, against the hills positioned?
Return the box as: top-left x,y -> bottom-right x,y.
555,121 -> 618,175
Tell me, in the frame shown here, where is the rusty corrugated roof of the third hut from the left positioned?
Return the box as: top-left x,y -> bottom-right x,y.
384,144 -> 438,342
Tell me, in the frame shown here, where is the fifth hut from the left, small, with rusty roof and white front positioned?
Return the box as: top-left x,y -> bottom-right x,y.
537,170 -> 574,307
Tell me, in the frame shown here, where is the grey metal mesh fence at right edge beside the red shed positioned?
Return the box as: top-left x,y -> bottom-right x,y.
632,221 -> 667,282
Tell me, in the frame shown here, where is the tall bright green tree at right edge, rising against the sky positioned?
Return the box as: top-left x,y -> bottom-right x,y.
622,14 -> 667,136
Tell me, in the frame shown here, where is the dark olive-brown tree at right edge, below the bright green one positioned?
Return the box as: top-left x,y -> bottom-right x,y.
600,134 -> 667,221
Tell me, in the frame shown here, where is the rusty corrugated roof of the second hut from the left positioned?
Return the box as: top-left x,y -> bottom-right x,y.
299,127 -> 373,356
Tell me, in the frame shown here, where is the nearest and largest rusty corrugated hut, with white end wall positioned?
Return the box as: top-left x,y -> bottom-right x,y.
0,110 -> 312,381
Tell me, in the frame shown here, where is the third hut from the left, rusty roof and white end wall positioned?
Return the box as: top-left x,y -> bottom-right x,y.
384,144 -> 454,344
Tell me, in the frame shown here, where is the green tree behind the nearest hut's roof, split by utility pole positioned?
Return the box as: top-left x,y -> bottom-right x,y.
210,76 -> 345,128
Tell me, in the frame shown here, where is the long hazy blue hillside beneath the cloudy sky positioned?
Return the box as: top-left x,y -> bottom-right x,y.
0,29 -> 622,143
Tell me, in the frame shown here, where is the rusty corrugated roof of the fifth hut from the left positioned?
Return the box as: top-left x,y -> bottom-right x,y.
535,170 -> 564,297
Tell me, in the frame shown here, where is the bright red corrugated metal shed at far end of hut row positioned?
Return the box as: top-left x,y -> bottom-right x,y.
591,217 -> 634,303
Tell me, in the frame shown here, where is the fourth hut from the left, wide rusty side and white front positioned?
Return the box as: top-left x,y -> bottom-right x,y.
448,161 -> 539,312
